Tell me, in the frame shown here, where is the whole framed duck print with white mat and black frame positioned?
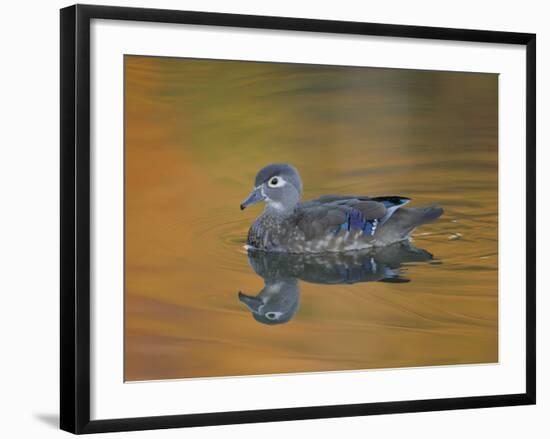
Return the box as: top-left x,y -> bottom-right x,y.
61,5 -> 535,433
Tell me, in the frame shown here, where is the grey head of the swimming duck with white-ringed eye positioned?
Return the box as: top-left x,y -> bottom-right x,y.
241,163 -> 302,215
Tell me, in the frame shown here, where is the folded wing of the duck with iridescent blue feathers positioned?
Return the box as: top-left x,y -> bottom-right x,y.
297,195 -> 410,240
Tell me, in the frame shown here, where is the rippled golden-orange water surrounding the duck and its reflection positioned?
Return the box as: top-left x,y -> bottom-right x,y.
125,56 -> 498,380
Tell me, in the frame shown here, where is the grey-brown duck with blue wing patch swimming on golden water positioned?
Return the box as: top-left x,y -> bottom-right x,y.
240,163 -> 443,254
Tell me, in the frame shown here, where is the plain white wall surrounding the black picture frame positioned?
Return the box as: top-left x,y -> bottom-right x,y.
0,0 -> 550,439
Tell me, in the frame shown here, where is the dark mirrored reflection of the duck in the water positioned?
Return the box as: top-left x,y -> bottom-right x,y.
239,241 -> 433,325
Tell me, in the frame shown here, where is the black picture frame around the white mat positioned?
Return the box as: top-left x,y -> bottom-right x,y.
60,5 -> 536,434
